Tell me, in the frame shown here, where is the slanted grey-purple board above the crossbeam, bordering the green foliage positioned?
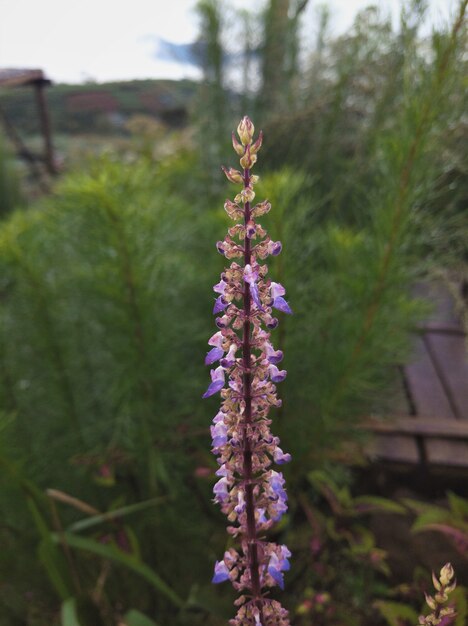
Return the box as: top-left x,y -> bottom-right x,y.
404,337 -> 455,419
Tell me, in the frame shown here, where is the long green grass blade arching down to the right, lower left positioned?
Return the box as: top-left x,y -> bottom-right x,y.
52,532 -> 184,607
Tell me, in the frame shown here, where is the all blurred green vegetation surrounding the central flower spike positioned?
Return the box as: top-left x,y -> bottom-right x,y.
0,0 -> 468,626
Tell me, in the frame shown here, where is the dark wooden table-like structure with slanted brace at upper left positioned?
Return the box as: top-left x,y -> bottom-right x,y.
0,69 -> 57,174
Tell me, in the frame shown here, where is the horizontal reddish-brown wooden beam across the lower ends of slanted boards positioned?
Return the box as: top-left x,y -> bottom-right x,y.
363,417 -> 468,441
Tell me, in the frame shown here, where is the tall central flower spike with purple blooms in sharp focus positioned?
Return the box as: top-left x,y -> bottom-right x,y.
203,117 -> 292,626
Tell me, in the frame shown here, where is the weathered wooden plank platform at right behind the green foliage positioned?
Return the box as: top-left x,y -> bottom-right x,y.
369,284 -> 468,469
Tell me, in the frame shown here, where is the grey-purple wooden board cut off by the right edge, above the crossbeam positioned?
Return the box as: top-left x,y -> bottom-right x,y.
424,333 -> 468,421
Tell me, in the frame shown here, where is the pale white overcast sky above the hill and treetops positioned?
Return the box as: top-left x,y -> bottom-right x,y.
0,0 -> 455,83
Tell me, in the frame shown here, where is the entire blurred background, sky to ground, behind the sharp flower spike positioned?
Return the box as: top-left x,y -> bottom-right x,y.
0,0 -> 468,626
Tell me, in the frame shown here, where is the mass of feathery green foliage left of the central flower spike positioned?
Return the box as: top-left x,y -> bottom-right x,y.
0,154 -> 227,610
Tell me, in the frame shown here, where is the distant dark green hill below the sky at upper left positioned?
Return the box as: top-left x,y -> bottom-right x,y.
0,80 -> 197,135
